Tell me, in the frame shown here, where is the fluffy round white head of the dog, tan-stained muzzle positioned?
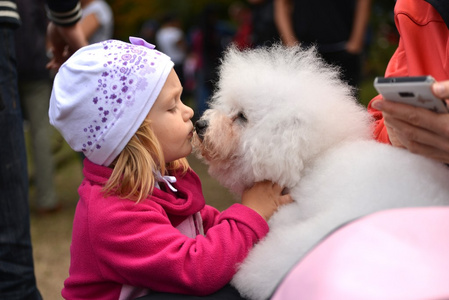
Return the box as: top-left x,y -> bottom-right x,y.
194,45 -> 371,194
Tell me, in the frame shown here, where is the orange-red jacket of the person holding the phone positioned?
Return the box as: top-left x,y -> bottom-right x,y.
368,0 -> 449,143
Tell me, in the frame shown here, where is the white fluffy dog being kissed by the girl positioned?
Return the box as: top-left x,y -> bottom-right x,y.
194,46 -> 449,299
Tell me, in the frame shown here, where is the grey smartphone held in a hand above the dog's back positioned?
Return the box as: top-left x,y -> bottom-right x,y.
374,76 -> 449,113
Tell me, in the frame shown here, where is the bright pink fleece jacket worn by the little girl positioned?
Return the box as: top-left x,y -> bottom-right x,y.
62,159 -> 268,300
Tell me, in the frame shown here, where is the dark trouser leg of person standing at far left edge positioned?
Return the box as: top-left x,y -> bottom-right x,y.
0,24 -> 41,300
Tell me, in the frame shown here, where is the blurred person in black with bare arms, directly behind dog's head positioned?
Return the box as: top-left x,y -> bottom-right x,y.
274,0 -> 371,88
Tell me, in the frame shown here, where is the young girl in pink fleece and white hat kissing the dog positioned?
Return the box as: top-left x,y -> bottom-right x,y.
49,38 -> 291,300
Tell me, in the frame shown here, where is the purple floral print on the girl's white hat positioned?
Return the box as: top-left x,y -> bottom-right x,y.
81,40 -> 161,154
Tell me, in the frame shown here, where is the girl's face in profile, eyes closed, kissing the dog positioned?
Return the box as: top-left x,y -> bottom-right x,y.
147,69 -> 193,163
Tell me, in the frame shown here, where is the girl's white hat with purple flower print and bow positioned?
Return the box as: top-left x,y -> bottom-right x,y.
49,37 -> 173,166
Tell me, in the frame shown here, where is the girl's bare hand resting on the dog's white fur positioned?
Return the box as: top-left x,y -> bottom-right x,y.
242,181 -> 293,221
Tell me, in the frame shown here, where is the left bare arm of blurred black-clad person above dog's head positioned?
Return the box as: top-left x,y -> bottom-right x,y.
274,0 -> 299,46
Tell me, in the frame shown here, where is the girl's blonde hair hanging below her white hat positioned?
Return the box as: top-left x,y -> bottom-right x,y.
103,119 -> 189,202
